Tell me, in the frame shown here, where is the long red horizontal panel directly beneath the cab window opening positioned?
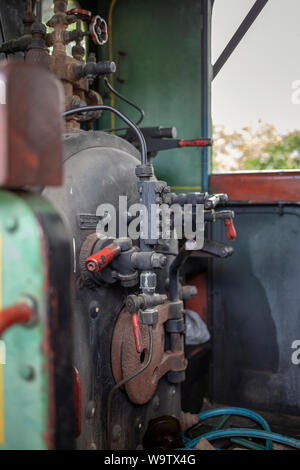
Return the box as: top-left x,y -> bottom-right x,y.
209,170 -> 300,203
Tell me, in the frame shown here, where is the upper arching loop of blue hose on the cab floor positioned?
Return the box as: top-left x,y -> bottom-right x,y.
184,407 -> 272,450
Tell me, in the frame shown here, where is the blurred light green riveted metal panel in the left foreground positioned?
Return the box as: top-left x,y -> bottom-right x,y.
0,191 -> 48,450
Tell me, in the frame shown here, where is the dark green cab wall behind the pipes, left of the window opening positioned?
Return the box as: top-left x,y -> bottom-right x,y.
98,0 -> 209,192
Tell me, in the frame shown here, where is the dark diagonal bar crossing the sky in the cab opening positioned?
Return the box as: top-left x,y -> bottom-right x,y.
213,0 -> 268,79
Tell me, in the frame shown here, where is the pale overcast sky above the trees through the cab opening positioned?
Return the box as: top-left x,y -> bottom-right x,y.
212,0 -> 300,133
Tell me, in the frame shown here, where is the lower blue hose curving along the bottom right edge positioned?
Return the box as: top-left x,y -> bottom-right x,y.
185,428 -> 300,450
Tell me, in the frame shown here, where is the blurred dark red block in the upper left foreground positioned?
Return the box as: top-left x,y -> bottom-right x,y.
0,61 -> 63,188
